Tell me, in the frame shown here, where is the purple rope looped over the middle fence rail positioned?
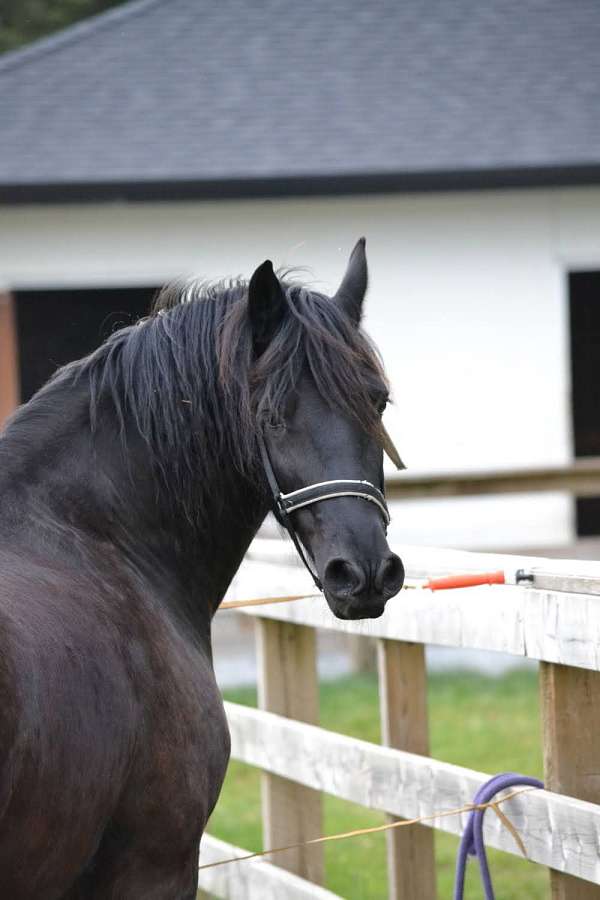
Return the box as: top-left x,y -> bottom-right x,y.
454,772 -> 544,900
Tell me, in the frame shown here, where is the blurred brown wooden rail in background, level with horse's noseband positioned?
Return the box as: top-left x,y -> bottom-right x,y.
385,457 -> 600,500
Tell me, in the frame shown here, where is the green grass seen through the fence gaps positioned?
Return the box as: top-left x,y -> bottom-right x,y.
209,671 -> 549,900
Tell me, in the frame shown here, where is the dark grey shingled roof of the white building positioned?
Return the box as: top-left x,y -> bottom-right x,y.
0,0 -> 600,201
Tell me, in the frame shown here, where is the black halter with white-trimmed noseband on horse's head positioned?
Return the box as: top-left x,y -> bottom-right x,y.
258,431 -> 390,591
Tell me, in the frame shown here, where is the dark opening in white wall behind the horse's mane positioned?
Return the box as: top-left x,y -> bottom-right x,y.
14,287 -> 156,403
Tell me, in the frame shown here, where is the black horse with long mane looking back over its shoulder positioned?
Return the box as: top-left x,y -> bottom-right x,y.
0,241 -> 403,900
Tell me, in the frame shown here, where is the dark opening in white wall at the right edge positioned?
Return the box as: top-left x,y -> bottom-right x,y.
569,271 -> 600,536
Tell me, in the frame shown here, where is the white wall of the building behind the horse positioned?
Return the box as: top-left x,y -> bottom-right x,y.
0,188 -> 600,548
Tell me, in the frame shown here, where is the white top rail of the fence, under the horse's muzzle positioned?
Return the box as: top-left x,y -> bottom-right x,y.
238,541 -> 600,671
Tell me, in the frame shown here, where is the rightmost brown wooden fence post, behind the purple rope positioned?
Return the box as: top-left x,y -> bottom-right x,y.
540,662 -> 600,900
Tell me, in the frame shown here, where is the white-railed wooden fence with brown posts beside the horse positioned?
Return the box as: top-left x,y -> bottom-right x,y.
200,541 -> 600,900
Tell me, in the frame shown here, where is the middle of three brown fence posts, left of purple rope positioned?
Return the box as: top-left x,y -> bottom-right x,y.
377,639 -> 436,900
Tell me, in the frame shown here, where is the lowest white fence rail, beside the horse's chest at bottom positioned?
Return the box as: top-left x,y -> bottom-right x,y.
198,834 -> 340,900
